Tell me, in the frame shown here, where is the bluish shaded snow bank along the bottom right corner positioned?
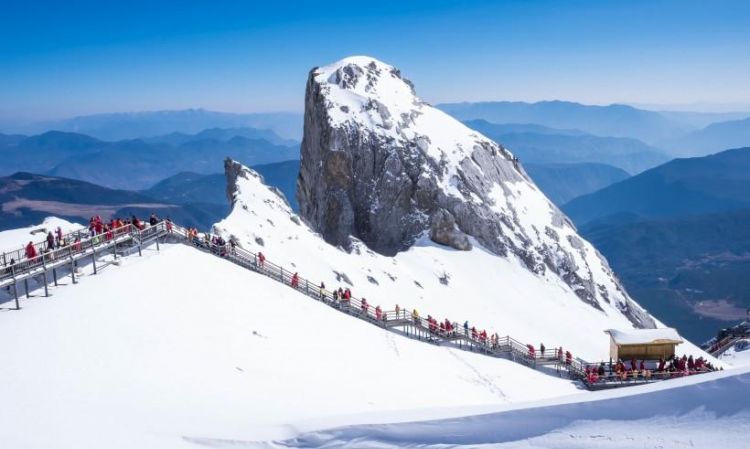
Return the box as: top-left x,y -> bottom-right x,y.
257,368 -> 750,449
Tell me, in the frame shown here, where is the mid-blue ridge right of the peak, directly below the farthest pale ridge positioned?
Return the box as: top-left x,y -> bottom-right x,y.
464,120 -> 670,174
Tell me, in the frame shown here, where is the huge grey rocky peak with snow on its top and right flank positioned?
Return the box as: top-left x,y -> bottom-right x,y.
297,57 -> 654,327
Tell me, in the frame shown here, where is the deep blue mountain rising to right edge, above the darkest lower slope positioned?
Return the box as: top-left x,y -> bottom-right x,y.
563,147 -> 750,227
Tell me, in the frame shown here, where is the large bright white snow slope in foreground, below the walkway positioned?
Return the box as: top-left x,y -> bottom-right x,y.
0,245 -> 577,449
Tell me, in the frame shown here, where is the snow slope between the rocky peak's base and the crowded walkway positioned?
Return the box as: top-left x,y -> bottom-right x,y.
214,163 -> 707,361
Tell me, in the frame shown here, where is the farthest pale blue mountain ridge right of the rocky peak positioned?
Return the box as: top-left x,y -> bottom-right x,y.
438,101 -> 693,143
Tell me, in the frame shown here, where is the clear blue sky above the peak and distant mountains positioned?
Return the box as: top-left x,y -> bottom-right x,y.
0,0 -> 750,121
